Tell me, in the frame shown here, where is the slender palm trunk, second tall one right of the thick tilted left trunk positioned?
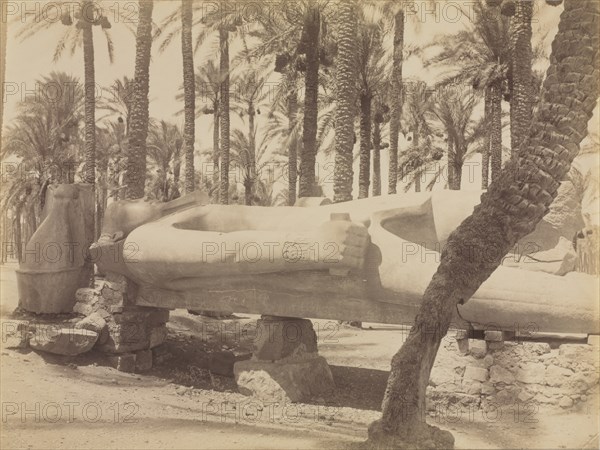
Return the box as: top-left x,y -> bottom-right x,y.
219,28 -> 229,205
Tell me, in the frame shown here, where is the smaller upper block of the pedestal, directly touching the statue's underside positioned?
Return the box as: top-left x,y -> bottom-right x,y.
253,317 -> 317,361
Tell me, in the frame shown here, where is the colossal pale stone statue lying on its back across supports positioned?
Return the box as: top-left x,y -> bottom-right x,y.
92,191 -> 600,334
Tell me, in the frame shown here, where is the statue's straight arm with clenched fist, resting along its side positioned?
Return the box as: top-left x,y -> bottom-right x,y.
125,221 -> 368,284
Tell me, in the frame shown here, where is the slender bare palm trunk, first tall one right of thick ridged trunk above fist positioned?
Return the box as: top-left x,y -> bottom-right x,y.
388,7 -> 404,194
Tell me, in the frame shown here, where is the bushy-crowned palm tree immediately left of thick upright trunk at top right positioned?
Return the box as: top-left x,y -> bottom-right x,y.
429,0 -> 511,188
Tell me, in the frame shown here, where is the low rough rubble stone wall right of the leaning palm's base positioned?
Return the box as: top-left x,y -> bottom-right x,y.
427,332 -> 600,411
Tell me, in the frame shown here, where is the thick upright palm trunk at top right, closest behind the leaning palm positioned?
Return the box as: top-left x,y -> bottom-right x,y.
510,0 -> 533,156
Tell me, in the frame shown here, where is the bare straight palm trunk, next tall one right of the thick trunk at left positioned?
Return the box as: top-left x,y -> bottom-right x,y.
181,0 -> 196,193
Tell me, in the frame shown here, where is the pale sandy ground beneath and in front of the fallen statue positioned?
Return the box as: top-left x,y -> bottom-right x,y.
0,264 -> 599,449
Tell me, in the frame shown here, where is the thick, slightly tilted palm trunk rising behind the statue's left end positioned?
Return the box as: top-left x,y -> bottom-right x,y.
123,0 -> 154,200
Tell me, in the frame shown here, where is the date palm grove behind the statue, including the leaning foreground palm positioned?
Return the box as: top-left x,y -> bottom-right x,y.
1,0 -> 599,446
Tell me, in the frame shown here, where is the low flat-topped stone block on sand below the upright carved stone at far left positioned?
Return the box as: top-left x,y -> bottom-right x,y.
29,327 -> 98,356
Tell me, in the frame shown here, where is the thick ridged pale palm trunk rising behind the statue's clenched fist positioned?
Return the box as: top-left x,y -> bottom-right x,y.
333,0 -> 356,202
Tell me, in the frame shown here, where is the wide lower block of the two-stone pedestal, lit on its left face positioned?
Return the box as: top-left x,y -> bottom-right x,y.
233,356 -> 335,402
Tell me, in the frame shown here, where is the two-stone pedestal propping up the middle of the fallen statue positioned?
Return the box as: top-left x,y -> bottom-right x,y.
233,316 -> 335,402
